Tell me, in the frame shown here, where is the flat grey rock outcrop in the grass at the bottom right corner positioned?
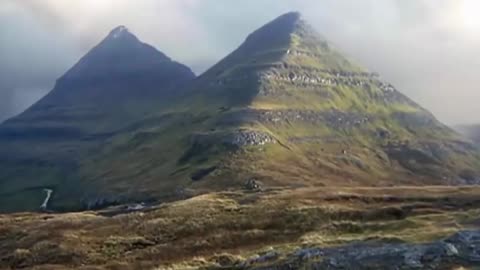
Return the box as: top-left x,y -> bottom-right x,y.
239,231 -> 480,270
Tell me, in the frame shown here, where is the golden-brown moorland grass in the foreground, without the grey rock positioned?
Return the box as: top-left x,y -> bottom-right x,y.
0,187 -> 480,269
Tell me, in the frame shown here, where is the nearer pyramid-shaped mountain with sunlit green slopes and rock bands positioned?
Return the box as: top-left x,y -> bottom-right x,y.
71,13 -> 480,210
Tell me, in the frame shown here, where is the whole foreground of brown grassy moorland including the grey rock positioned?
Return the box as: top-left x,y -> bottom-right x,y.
0,187 -> 480,270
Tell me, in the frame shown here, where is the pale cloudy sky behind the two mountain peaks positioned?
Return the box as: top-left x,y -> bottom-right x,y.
0,0 -> 480,124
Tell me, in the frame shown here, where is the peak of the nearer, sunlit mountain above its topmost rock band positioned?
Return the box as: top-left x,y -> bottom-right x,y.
204,11 -> 354,81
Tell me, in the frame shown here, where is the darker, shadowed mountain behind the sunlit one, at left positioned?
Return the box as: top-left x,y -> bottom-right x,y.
0,26 -> 195,212
